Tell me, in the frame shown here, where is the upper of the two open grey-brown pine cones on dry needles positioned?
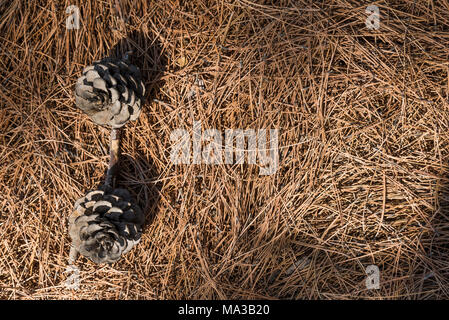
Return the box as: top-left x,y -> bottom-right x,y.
75,58 -> 145,128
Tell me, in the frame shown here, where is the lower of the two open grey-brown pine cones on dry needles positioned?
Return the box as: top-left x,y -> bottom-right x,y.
69,189 -> 144,263
